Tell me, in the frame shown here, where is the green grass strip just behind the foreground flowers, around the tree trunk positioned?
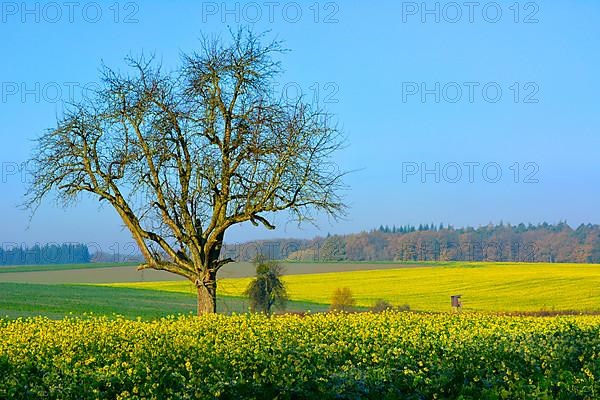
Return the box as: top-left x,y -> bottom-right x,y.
0,283 -> 327,319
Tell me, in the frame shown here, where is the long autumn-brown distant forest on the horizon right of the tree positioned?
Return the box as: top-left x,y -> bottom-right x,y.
224,222 -> 600,263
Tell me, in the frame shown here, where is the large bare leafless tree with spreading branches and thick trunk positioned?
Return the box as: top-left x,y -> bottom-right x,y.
25,30 -> 345,314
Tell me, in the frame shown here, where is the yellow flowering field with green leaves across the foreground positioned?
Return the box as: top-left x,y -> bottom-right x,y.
0,312 -> 600,399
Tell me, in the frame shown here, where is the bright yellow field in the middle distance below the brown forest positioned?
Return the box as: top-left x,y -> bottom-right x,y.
102,263 -> 600,312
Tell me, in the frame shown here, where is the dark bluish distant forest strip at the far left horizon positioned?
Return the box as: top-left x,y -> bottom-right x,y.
0,243 -> 91,265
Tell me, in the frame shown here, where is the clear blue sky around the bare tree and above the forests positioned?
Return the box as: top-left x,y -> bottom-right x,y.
0,0 -> 600,251
